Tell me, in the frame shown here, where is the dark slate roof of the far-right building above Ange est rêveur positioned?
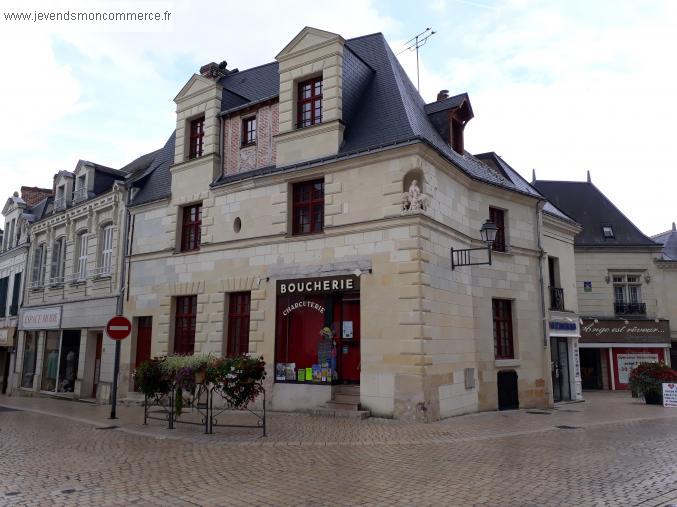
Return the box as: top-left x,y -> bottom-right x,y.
533,181 -> 660,247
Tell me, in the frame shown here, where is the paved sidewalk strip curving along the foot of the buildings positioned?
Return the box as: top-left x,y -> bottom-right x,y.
0,391 -> 677,446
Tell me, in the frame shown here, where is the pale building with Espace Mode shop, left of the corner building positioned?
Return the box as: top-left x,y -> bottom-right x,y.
15,154 -> 154,401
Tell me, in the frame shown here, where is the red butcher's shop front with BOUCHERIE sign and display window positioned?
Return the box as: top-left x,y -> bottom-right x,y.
275,275 -> 361,384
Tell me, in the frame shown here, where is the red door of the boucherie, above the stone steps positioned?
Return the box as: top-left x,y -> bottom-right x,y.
337,299 -> 360,384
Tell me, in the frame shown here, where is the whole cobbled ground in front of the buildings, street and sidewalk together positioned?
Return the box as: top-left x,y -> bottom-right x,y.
0,393 -> 677,507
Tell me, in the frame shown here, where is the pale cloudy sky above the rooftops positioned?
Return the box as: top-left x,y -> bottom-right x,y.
0,0 -> 677,234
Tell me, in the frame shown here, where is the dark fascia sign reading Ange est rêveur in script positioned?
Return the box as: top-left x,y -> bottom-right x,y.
581,319 -> 670,343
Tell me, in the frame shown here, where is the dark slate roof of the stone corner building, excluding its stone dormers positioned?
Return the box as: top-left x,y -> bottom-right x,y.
134,33 -> 556,206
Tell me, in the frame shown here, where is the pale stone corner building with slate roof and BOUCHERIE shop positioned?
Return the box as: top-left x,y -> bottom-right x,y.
113,28 -> 580,420
